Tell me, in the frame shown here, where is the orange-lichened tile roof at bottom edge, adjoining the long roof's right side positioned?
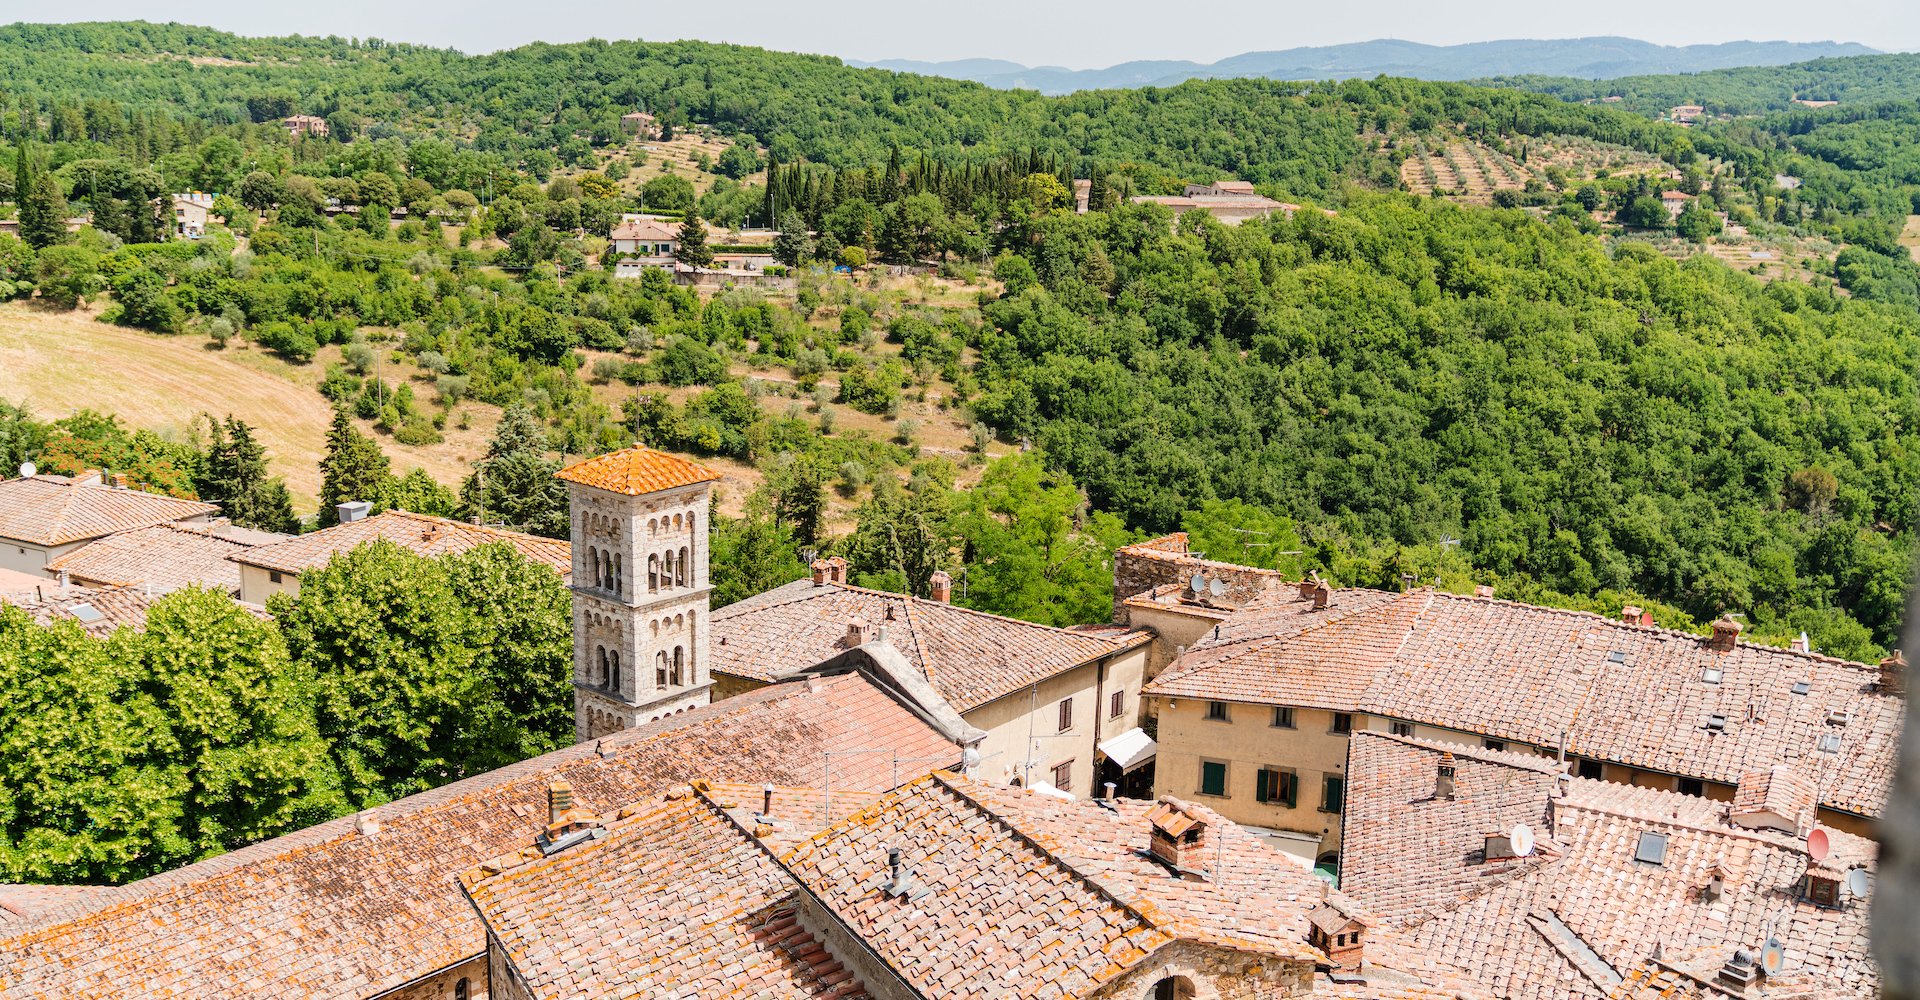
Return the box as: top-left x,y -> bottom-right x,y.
461,795 -> 866,1000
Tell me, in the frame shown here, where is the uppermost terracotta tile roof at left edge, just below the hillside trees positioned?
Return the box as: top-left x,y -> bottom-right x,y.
0,476 -> 219,545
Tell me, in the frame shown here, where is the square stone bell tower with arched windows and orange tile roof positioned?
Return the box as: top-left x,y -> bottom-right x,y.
559,447 -> 720,741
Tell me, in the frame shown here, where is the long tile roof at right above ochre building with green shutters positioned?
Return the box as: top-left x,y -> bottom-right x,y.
1146,589 -> 1907,816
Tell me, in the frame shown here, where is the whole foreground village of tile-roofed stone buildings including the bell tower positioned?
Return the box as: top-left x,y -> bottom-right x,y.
0,447 -> 1907,1000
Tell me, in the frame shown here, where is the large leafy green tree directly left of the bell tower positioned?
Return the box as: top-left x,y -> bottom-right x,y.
271,541 -> 572,806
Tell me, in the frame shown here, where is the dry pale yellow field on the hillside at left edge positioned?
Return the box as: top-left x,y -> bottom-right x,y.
0,303 -> 499,512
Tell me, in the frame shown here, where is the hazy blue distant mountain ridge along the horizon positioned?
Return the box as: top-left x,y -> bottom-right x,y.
864,36 -> 1878,94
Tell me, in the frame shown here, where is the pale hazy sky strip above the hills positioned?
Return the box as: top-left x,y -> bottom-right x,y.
0,0 -> 1920,69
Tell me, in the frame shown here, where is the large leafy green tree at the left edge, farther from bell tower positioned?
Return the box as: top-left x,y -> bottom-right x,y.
0,589 -> 346,883
